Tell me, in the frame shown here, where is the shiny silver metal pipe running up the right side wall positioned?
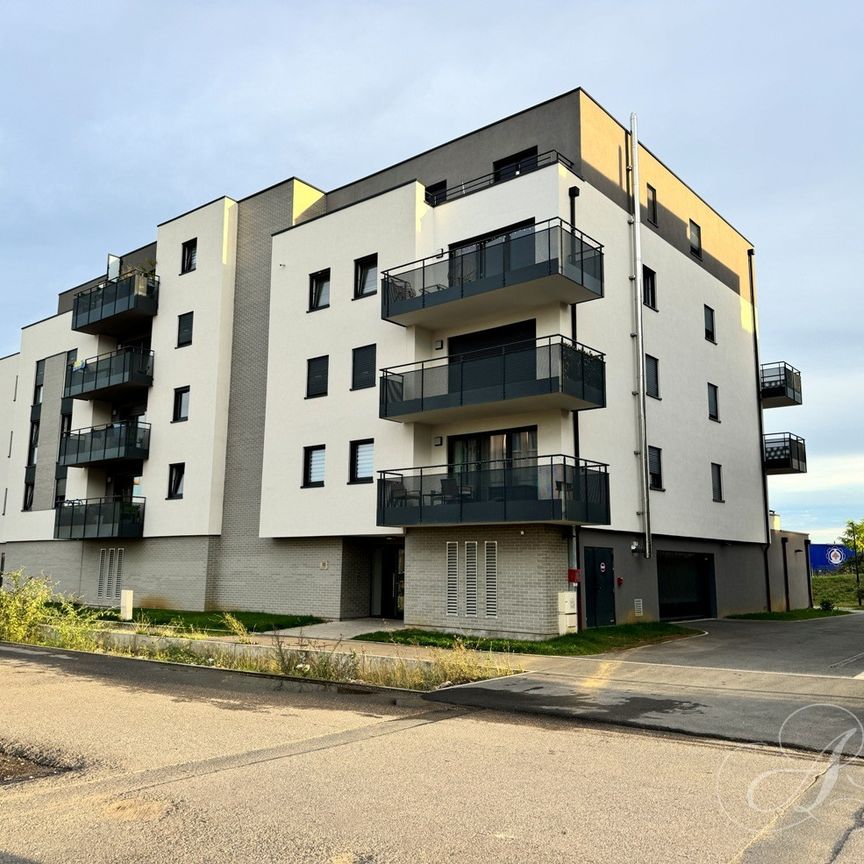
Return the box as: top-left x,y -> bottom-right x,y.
629,113 -> 651,558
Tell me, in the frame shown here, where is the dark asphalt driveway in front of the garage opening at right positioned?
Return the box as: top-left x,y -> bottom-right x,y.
601,613 -> 864,678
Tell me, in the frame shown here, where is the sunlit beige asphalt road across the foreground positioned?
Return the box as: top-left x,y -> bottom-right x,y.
0,645 -> 864,864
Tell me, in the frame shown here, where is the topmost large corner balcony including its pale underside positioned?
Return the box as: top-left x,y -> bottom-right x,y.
381,219 -> 603,329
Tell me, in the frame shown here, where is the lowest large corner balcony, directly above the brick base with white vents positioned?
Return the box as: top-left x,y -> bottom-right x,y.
378,455 -> 609,527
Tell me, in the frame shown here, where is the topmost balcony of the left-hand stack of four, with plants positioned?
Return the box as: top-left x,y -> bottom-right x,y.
72,273 -> 159,338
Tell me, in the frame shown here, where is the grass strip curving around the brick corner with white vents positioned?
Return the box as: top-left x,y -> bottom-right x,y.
355,622 -> 702,656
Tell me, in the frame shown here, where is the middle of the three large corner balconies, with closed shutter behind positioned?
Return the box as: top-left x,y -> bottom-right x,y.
379,336 -> 606,423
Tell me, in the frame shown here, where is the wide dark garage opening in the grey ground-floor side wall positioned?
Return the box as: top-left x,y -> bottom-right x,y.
657,552 -> 717,620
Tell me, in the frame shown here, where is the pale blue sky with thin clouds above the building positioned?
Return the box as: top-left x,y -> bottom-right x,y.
0,0 -> 864,542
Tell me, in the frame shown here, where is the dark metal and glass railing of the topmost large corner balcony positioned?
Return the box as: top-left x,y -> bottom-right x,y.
381,219 -> 603,319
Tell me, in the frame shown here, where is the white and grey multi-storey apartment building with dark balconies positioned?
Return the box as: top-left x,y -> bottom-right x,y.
0,89 -> 806,638
